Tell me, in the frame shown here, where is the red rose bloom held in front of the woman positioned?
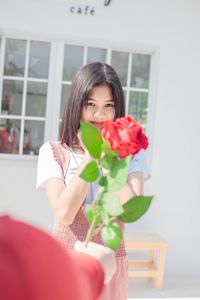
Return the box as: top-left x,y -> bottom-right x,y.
102,116 -> 148,158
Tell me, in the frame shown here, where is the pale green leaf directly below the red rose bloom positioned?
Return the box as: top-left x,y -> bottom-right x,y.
107,156 -> 131,192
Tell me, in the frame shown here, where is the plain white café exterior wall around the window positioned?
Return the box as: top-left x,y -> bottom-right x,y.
0,0 -> 200,275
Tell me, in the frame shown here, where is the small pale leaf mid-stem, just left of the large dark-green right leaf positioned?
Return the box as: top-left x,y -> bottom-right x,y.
102,193 -> 124,217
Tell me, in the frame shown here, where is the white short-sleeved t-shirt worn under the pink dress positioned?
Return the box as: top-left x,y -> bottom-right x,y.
36,142 -> 150,203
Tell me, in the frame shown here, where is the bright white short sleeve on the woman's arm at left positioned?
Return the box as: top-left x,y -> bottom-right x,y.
36,142 -> 64,189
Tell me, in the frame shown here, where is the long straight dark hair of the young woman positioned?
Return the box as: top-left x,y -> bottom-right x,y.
60,62 -> 125,149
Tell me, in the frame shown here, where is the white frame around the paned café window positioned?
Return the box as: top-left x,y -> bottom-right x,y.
0,32 -> 159,171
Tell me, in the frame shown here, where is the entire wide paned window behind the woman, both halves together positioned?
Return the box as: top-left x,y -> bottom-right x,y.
0,38 -> 151,155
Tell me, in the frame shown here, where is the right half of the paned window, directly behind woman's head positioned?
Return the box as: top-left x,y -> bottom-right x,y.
60,45 -> 151,129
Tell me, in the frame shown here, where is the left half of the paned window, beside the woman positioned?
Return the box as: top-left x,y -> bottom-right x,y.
0,39 -> 50,155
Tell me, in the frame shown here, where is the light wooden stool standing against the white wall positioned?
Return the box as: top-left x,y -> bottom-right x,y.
125,232 -> 167,290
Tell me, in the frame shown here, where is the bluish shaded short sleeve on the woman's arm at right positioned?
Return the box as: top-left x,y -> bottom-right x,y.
128,149 -> 150,181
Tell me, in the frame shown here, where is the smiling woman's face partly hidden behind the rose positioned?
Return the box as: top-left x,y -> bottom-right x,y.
81,85 -> 115,131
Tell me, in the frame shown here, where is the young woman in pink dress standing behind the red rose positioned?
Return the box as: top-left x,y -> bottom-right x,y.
37,62 -> 146,300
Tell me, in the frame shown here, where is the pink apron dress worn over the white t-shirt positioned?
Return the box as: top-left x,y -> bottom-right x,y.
51,142 -> 128,300
